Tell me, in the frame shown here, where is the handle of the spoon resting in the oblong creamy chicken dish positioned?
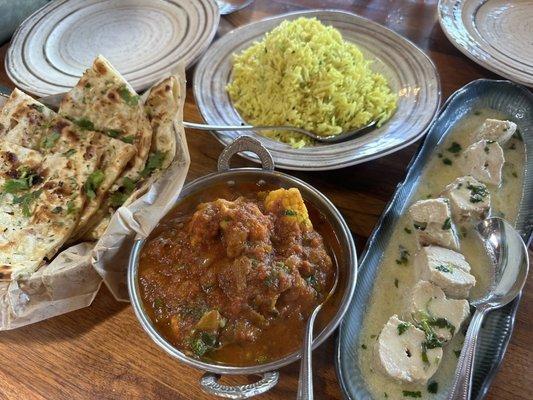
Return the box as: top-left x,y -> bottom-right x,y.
448,307 -> 489,400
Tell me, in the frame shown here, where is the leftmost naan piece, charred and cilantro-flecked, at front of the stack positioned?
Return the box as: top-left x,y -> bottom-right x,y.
0,135 -> 101,280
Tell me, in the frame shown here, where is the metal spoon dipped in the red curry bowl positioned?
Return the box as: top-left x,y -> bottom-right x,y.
296,255 -> 339,400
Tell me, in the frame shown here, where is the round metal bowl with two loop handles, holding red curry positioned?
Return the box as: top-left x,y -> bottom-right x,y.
128,136 -> 357,399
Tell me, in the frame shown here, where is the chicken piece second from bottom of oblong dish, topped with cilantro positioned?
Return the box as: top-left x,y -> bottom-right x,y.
409,281 -> 470,342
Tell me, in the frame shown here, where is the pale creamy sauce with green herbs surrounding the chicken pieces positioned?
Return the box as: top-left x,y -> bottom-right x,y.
358,109 -> 525,400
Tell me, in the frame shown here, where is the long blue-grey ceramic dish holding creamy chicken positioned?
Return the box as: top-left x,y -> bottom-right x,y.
335,79 -> 533,399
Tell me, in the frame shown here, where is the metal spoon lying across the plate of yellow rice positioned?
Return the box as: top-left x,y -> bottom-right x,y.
183,121 -> 377,143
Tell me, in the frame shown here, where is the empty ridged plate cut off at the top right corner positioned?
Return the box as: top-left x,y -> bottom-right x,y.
439,0 -> 533,87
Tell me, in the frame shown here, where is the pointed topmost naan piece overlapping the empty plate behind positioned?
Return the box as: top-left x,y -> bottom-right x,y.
59,56 -> 152,181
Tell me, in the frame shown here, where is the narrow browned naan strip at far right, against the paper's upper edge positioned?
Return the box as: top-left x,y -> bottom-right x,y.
144,76 -> 180,169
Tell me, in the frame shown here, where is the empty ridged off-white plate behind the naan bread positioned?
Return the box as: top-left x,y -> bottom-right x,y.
5,0 -> 219,96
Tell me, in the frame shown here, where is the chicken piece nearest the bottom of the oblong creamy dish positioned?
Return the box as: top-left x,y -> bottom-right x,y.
375,315 -> 442,384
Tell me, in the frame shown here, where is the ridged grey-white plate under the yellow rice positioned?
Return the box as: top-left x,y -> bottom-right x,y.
193,11 -> 440,170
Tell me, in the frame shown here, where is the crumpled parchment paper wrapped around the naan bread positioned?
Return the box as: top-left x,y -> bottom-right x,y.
0,66 -> 190,330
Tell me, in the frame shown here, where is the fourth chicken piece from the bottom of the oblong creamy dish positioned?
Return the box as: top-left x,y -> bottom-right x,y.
409,198 -> 459,250
